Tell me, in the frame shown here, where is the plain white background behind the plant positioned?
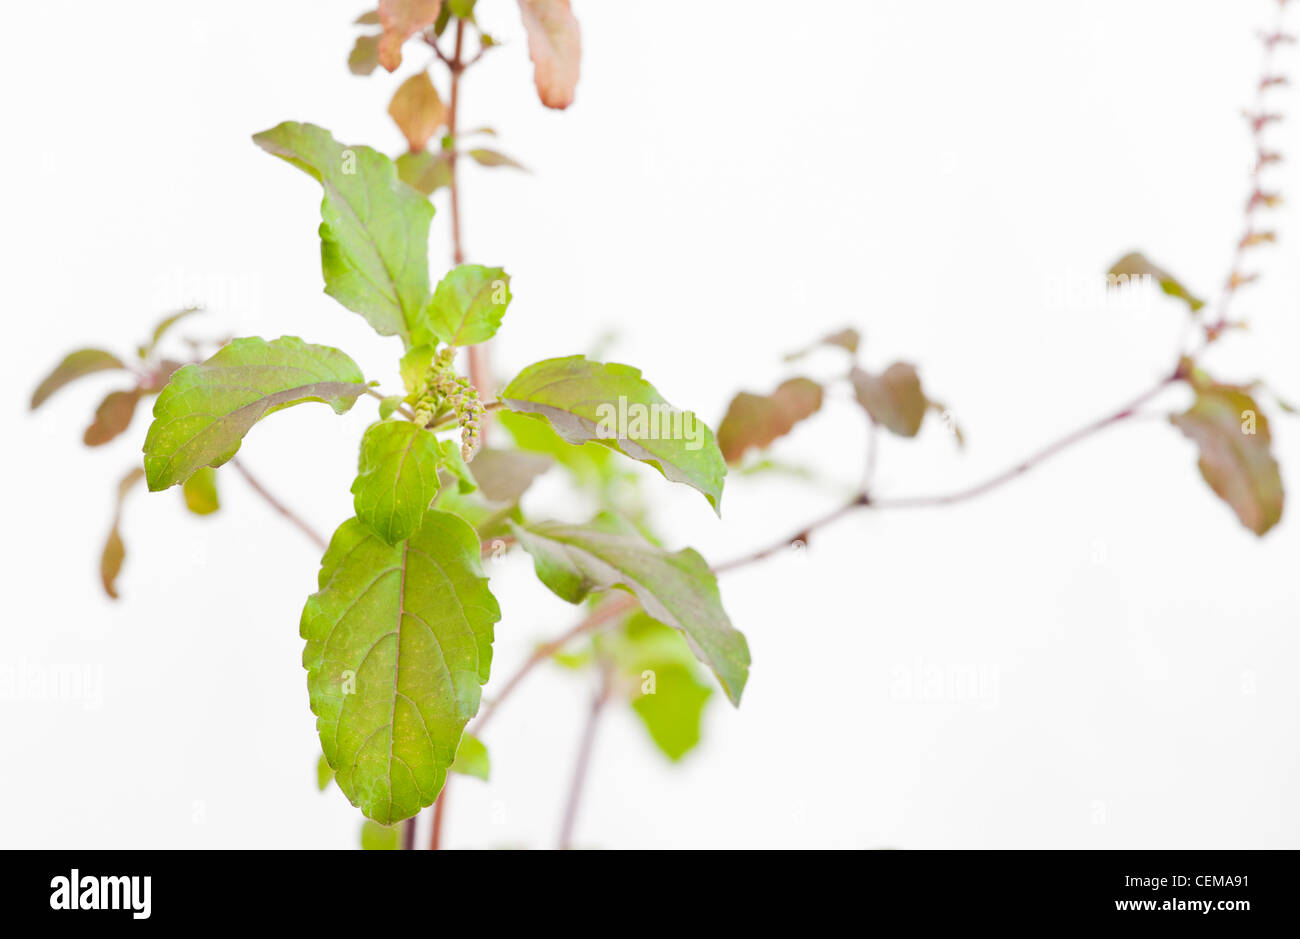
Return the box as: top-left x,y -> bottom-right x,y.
0,0 -> 1300,848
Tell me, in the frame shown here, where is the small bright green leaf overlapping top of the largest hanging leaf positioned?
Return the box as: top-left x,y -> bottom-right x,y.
352,420 -> 442,545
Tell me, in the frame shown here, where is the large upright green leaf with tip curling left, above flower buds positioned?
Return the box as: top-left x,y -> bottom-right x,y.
254,121 -> 433,345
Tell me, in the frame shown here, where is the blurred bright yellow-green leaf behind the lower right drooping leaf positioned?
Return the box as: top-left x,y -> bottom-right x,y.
599,611 -> 714,762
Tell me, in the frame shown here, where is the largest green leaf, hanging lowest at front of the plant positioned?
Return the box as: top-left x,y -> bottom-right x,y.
302,510 -> 501,825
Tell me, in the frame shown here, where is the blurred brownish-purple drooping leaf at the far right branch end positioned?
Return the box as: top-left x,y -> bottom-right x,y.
1170,385 -> 1284,535
